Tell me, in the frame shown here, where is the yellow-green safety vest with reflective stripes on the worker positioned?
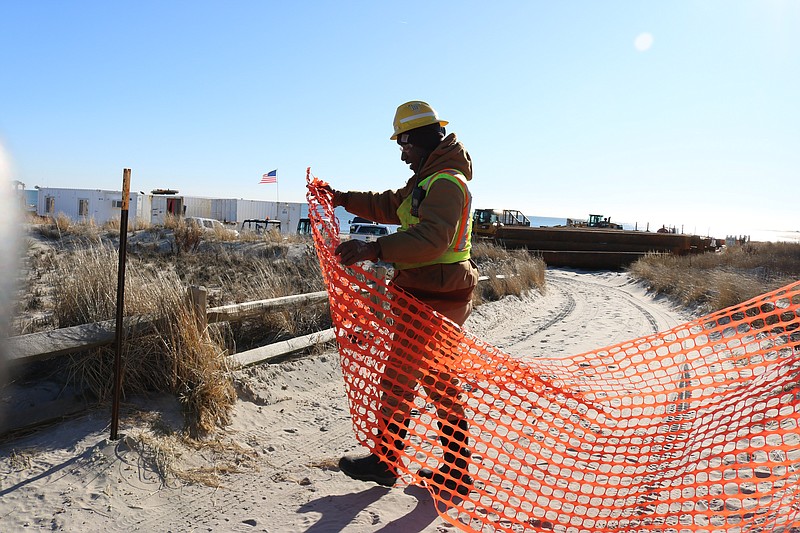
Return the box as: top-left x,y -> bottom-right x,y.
394,169 -> 472,270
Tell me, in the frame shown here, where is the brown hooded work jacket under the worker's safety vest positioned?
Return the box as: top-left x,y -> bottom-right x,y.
336,133 -> 478,324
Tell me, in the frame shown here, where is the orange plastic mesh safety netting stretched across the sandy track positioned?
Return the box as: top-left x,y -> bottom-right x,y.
308,172 -> 800,533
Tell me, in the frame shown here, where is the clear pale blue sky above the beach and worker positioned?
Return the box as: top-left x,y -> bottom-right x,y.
0,0 -> 800,236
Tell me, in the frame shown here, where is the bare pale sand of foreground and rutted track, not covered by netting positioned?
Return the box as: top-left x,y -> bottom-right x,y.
0,269 -> 692,533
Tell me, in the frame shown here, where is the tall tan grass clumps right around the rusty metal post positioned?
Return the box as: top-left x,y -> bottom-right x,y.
53,243 -> 235,436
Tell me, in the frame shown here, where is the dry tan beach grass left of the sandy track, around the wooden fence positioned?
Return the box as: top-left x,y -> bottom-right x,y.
16,217 -> 545,437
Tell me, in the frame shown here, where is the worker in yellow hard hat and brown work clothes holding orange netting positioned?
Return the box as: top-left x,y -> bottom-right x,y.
331,101 -> 478,495
